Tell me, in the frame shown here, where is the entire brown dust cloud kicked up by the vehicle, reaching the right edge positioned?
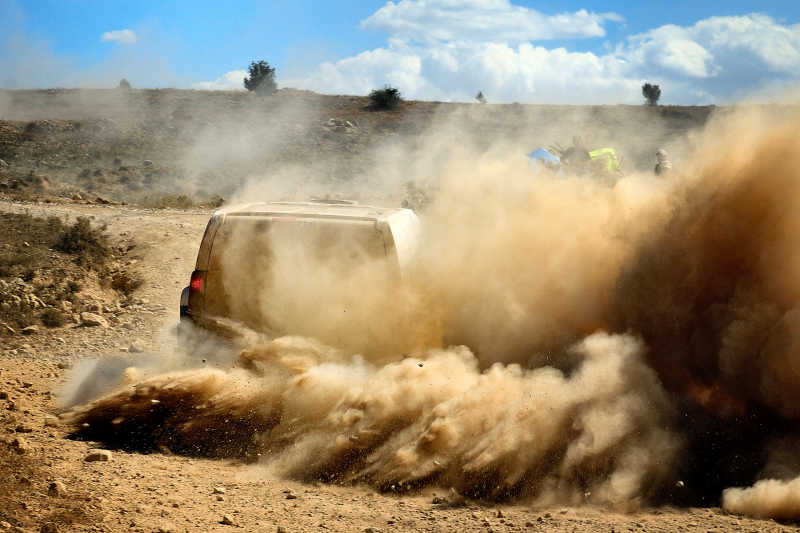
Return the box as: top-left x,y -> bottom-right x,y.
67,98 -> 800,517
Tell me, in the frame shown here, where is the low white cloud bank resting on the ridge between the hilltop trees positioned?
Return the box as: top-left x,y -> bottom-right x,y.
283,42 -> 641,103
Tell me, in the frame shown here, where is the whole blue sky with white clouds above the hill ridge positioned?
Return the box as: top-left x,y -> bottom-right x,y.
0,0 -> 800,104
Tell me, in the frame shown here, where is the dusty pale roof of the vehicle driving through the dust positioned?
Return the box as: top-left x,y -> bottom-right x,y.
214,200 -> 404,220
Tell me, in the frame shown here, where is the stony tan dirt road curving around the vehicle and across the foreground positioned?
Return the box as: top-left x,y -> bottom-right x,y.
0,197 -> 796,533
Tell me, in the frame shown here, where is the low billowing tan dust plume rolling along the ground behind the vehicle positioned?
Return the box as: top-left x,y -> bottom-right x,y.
70,333 -> 680,507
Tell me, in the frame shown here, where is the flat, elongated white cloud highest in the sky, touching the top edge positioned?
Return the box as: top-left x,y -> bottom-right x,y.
361,0 -> 622,43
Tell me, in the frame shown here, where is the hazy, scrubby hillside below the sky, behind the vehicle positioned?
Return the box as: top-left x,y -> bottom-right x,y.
0,89 -> 715,204
